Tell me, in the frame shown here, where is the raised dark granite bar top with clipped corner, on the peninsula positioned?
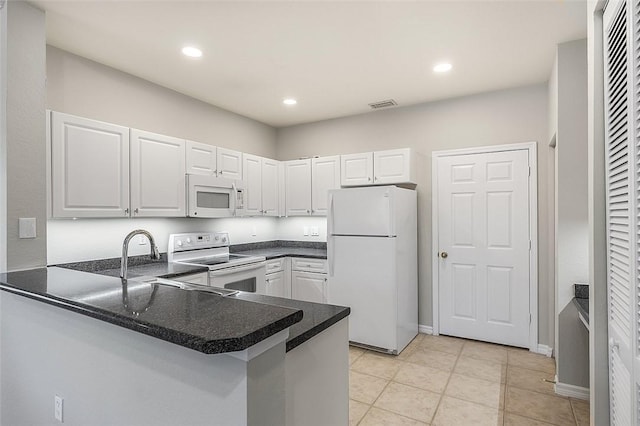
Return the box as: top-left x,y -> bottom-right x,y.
0,267 -> 304,354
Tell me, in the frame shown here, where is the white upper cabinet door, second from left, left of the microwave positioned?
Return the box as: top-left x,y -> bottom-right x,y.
131,129 -> 186,217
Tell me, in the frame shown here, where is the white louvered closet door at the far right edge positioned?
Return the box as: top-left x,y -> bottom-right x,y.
603,0 -> 640,426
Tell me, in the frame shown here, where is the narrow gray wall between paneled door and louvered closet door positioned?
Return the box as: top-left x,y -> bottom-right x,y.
549,40 -> 589,388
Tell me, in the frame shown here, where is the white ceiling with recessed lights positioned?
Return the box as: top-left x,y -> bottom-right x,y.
32,0 -> 587,127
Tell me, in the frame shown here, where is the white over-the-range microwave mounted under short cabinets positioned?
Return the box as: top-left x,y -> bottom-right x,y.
186,175 -> 245,218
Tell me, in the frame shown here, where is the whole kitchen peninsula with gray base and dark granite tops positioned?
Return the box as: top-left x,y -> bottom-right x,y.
0,267 -> 349,425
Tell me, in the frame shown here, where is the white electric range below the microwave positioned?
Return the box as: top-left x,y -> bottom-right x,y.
167,232 -> 266,294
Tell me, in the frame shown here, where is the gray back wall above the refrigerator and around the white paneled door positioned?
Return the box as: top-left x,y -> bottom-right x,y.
277,84 -> 554,346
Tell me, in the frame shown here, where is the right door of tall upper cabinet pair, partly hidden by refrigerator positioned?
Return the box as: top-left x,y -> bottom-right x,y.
311,155 -> 340,216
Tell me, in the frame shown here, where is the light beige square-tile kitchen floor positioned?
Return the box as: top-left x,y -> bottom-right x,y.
349,334 -> 589,426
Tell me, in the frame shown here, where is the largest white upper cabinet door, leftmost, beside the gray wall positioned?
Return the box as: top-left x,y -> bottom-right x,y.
51,112 -> 129,218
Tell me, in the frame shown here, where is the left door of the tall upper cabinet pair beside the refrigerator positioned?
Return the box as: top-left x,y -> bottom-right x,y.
285,159 -> 311,216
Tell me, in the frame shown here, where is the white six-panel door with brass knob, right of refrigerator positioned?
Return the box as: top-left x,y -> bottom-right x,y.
434,149 -> 530,347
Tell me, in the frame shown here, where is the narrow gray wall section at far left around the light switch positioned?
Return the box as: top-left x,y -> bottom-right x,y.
7,2 -> 47,270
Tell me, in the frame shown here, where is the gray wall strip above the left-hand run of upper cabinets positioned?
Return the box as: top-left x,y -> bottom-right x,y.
47,46 -> 276,158
